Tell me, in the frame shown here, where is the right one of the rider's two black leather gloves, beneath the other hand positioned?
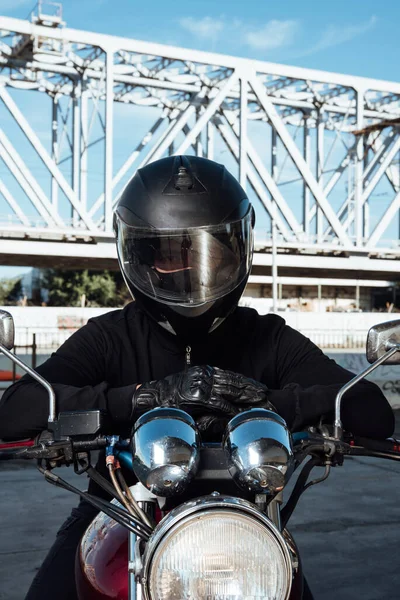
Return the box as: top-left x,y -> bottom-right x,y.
214,367 -> 276,412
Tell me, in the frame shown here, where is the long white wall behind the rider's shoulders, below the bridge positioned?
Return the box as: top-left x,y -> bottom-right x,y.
0,299 -> 400,408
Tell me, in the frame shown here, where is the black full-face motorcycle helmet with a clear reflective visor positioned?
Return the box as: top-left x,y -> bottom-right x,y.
114,156 -> 254,341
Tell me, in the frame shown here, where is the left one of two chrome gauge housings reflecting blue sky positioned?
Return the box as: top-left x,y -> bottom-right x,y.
131,408 -> 200,497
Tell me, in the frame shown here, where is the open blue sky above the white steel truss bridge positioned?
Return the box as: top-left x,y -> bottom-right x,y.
0,0 -> 400,277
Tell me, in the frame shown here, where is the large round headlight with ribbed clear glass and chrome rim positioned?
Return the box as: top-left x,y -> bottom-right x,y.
143,496 -> 292,600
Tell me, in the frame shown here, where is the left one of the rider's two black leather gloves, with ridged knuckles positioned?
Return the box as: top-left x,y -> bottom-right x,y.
131,365 -> 238,421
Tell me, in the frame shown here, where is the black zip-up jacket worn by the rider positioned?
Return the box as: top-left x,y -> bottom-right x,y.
0,302 -> 394,440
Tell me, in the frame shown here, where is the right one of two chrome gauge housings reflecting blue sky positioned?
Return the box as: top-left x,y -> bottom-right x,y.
223,408 -> 294,496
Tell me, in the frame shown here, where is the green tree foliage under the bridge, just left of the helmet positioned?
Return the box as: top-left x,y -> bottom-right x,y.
44,269 -> 128,307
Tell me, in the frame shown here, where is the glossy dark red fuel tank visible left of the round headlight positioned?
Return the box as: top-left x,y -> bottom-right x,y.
75,513 -> 129,600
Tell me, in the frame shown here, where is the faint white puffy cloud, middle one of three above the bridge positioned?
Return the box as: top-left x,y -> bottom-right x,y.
243,19 -> 299,50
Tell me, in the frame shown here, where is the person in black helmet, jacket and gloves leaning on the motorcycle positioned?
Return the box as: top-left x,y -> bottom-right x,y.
0,156 -> 394,600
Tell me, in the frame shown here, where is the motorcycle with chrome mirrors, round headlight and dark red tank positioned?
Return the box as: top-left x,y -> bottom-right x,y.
0,311 -> 400,600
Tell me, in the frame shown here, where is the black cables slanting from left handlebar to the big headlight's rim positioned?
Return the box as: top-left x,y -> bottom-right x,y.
38,466 -> 152,541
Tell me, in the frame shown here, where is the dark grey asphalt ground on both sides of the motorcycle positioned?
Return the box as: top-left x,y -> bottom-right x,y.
0,413 -> 400,600
